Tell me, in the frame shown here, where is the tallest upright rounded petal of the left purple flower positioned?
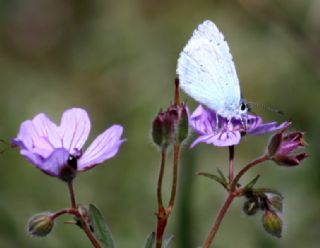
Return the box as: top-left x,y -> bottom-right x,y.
59,108 -> 91,154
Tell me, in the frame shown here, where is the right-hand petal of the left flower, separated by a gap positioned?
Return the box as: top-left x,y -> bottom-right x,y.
78,125 -> 125,171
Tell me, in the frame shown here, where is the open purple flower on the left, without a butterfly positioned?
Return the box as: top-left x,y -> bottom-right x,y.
12,108 -> 124,181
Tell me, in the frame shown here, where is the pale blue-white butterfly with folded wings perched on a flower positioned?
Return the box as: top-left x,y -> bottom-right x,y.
177,20 -> 248,120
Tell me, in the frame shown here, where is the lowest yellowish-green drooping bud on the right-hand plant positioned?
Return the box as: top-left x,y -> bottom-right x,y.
262,210 -> 283,238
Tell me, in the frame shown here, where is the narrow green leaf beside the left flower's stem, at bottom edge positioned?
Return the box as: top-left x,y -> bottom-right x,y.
89,204 -> 115,248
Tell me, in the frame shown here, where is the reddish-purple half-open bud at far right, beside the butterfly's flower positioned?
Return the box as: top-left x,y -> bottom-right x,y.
268,123 -> 308,166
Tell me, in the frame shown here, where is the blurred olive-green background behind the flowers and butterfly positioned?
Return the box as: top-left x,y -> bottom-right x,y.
0,0 -> 320,248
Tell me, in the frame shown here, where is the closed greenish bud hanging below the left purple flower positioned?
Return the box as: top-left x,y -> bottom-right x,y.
28,213 -> 54,237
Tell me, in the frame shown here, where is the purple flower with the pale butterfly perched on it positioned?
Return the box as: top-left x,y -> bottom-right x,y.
190,105 -> 287,147
